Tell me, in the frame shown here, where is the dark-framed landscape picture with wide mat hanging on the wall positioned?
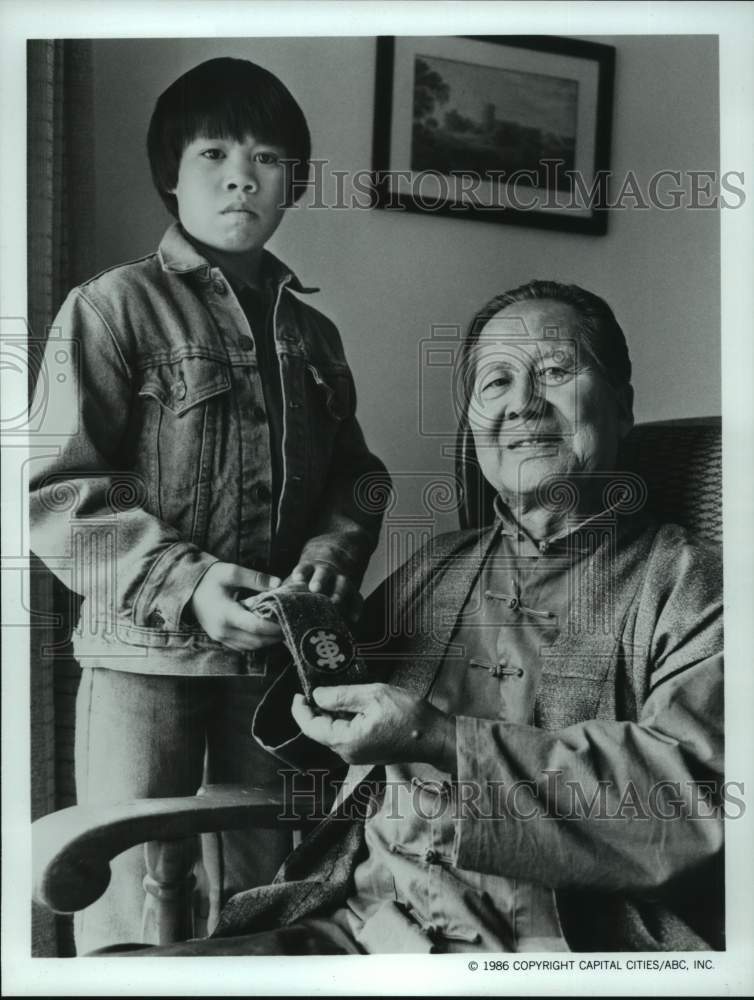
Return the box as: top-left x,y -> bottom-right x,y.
373,35 -> 615,235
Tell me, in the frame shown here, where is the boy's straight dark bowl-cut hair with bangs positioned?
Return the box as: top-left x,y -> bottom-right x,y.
147,58 -> 311,218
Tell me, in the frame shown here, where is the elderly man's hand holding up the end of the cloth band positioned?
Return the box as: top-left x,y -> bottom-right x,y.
291,684 -> 456,773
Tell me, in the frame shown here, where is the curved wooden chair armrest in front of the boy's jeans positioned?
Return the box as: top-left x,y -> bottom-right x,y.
32,785 -> 314,913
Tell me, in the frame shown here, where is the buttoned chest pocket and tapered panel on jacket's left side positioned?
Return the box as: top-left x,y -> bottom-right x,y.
136,355 -> 231,546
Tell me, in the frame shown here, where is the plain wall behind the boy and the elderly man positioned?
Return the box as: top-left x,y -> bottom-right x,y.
88,35 -> 720,585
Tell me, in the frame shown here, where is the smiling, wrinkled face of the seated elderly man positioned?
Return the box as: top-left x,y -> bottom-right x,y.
469,300 -> 633,499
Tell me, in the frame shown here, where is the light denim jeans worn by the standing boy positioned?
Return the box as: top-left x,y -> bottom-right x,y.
74,661 -> 291,955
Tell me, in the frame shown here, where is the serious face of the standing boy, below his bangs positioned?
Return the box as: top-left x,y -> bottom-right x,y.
171,134 -> 287,253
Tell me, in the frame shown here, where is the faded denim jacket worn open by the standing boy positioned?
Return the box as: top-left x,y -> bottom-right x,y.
30,224 -> 389,675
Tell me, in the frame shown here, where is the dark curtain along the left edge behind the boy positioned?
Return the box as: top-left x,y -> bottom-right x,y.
26,39 -> 94,957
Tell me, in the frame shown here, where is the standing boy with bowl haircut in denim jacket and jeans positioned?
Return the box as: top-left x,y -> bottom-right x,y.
30,59 -> 385,954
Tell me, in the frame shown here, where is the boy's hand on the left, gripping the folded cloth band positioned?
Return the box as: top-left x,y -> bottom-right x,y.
191,562 -> 282,653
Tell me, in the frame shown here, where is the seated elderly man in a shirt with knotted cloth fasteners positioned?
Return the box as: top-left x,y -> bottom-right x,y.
114,282 -> 723,955
